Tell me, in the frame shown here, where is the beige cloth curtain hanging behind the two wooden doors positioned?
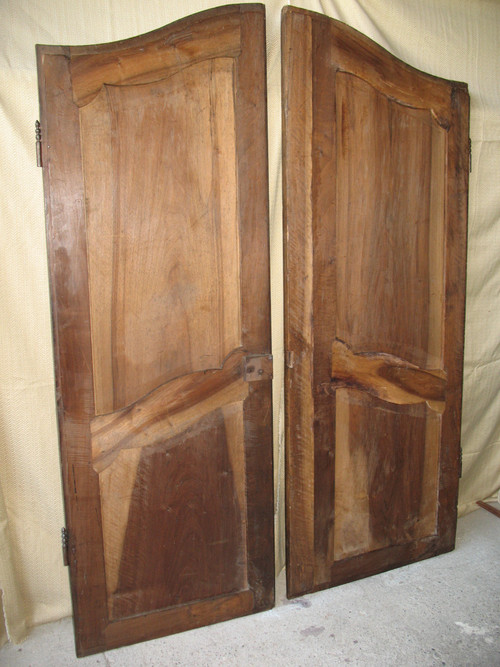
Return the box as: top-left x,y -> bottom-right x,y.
0,0 -> 500,644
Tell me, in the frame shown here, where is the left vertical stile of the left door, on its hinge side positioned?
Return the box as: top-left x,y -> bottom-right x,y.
37,48 -> 106,653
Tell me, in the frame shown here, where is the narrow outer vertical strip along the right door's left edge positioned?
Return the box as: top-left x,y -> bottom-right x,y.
282,9 -> 314,592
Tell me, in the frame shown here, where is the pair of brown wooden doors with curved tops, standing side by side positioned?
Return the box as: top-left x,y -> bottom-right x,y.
38,5 -> 467,655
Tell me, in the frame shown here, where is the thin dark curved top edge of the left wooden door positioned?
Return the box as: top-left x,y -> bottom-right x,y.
35,3 -> 265,56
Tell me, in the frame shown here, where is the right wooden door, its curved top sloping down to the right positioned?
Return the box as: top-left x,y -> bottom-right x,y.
282,8 -> 469,596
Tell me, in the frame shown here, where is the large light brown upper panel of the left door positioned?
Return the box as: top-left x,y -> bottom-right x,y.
80,58 -> 241,415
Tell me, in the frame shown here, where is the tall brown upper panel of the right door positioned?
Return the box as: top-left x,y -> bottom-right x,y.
335,72 -> 446,369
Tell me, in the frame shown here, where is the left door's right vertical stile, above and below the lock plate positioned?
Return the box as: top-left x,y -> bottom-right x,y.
234,5 -> 274,611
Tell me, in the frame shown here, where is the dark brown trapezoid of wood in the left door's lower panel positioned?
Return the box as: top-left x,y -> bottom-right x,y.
110,410 -> 248,619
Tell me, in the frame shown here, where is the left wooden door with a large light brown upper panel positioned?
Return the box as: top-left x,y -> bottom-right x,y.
37,5 -> 274,655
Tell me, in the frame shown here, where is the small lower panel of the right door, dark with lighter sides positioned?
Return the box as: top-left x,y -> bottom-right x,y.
330,389 -> 441,564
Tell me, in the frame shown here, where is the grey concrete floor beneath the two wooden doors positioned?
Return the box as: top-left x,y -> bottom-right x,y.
0,505 -> 500,667
